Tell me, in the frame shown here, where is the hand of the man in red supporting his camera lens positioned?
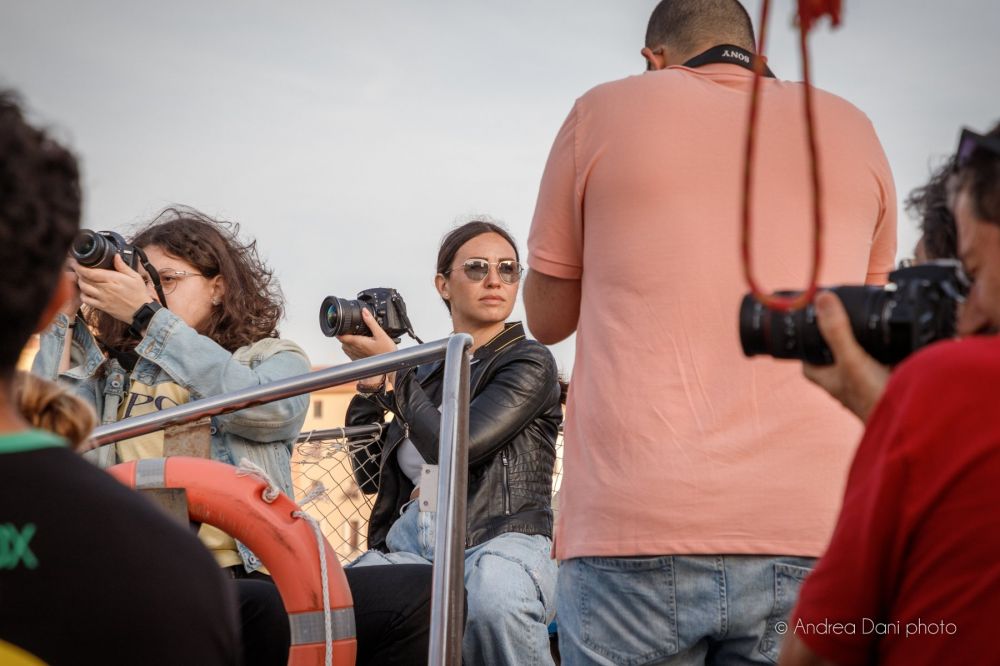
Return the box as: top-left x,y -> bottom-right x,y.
802,291 -> 890,422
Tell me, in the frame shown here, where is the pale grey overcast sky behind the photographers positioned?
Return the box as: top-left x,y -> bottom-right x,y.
0,0 -> 1000,370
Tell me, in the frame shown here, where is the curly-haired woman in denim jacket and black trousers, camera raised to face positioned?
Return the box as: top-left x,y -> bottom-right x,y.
32,208 -> 431,666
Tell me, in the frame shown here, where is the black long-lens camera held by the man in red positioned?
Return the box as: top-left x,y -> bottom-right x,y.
740,260 -> 969,365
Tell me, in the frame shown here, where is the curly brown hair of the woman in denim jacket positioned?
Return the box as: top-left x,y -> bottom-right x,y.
88,206 -> 284,351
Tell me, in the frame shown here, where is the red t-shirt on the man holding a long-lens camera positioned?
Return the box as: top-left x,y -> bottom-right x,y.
790,337 -> 1000,665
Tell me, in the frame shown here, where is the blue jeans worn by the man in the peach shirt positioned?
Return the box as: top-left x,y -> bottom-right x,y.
557,555 -> 816,666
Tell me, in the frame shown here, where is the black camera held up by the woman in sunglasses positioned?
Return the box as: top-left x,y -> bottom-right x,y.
319,287 -> 416,343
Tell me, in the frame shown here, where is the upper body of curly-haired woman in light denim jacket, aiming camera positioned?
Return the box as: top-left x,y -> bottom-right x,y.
32,208 -> 310,576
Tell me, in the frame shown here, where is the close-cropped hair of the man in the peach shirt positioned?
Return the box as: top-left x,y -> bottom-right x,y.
646,0 -> 756,55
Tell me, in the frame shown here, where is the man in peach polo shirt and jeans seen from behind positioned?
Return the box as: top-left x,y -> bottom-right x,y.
524,0 -> 896,664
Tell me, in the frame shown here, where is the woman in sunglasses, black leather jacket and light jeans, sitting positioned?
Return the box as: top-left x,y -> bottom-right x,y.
339,221 -> 562,664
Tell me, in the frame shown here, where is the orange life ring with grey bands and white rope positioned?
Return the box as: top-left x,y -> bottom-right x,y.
108,456 -> 357,666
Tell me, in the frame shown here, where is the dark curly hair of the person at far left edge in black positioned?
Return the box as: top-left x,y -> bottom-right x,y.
0,91 -> 82,380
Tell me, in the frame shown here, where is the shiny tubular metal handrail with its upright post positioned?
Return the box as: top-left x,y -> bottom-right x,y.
93,333 -> 472,666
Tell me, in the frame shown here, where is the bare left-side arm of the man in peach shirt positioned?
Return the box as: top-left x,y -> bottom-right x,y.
524,270 -> 580,345
